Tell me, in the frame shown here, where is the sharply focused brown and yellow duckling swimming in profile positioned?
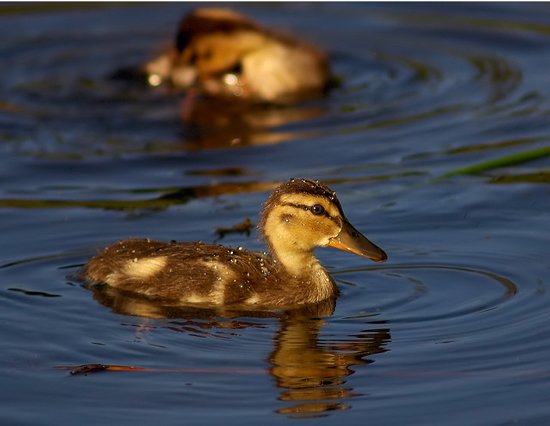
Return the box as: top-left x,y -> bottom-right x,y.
81,179 -> 387,310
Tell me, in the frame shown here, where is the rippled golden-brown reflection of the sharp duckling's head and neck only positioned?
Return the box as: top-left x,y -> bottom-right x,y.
269,313 -> 391,416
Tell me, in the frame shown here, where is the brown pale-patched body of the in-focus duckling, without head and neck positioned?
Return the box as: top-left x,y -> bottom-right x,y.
82,239 -> 286,305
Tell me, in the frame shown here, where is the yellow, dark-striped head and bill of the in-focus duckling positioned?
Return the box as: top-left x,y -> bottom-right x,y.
259,179 -> 387,269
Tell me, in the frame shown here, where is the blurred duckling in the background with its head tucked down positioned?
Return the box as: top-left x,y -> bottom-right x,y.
144,7 -> 331,103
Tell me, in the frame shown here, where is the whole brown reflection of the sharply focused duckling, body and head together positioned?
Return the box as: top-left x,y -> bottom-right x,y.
92,286 -> 391,416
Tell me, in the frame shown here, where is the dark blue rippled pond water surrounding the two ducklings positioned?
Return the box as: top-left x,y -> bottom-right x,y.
0,3 -> 550,425
